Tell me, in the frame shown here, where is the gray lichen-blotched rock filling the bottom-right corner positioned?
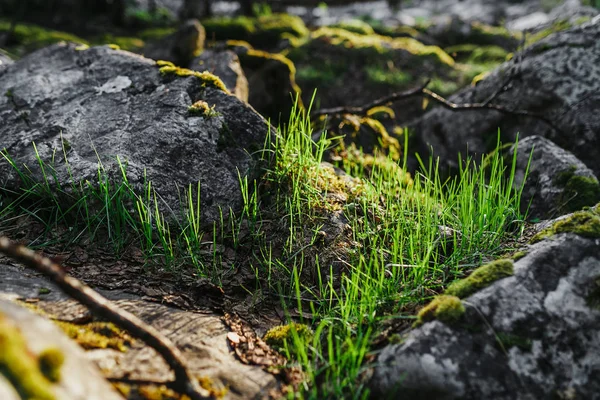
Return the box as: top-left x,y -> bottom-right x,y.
370,233 -> 600,400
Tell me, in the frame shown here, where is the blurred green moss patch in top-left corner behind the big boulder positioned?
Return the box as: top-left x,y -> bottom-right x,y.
0,21 -> 88,56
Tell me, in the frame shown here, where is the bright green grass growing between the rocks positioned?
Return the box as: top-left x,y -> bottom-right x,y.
0,98 -> 524,399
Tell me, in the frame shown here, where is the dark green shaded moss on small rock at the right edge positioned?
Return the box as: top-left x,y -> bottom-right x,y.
554,166 -> 600,213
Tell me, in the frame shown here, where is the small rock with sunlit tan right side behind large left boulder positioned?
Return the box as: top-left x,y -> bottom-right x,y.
189,50 -> 248,102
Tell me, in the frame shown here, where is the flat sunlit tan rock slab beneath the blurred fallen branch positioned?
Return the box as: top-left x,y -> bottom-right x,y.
0,264 -> 278,400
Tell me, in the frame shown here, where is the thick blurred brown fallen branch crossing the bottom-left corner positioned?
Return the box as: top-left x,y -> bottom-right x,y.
0,236 -> 210,400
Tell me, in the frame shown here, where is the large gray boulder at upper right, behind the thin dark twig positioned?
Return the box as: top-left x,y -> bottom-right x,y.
412,19 -> 600,174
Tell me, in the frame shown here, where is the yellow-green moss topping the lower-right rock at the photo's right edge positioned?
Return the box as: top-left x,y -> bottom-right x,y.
531,205 -> 600,243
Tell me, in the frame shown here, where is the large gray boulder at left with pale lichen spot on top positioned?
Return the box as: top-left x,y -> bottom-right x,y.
0,44 -> 268,222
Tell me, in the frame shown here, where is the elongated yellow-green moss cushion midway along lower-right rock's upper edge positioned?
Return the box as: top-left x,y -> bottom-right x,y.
444,259 -> 514,299
